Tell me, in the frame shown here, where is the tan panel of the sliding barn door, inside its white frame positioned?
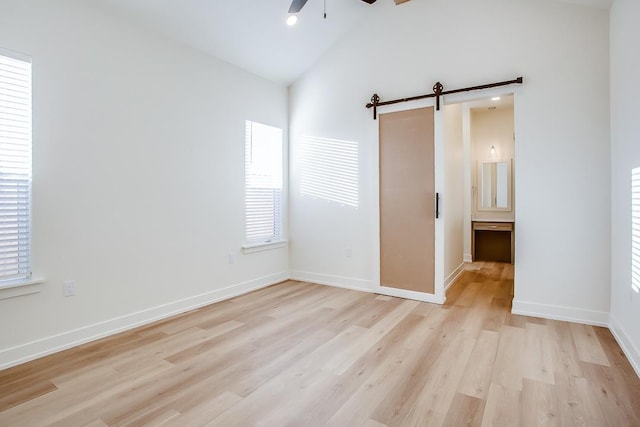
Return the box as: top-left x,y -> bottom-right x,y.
380,107 -> 435,294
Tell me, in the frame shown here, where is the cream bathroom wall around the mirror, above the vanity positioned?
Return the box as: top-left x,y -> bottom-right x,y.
471,107 -> 516,221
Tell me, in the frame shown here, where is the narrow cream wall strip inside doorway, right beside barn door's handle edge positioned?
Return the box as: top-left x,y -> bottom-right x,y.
442,104 -> 470,286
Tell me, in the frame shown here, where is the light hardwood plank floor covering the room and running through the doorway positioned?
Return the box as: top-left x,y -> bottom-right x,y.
0,263 -> 640,427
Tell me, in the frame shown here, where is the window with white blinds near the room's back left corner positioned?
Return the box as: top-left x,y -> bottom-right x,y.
245,120 -> 282,245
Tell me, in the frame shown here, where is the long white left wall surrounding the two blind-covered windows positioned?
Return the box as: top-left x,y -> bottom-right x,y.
0,0 -> 288,368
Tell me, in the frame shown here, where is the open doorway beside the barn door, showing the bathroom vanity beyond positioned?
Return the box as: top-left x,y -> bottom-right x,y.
443,92 -> 517,306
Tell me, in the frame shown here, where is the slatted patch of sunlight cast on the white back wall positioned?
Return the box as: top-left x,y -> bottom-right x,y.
300,136 -> 359,208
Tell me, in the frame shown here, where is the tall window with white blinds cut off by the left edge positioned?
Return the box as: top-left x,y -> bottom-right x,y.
0,50 -> 31,287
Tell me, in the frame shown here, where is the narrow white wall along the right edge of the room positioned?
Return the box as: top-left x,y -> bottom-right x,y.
610,0 -> 640,375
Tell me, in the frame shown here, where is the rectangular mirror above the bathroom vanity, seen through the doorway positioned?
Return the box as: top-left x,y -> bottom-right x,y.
478,160 -> 511,211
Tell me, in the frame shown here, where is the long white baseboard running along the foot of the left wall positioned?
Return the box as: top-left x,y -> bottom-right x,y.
0,272 -> 289,369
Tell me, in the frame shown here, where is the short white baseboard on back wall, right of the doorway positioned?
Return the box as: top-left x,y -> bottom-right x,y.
511,299 -> 609,327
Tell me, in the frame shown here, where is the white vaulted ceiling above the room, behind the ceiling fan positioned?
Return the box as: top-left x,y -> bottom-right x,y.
99,0 -> 613,85
